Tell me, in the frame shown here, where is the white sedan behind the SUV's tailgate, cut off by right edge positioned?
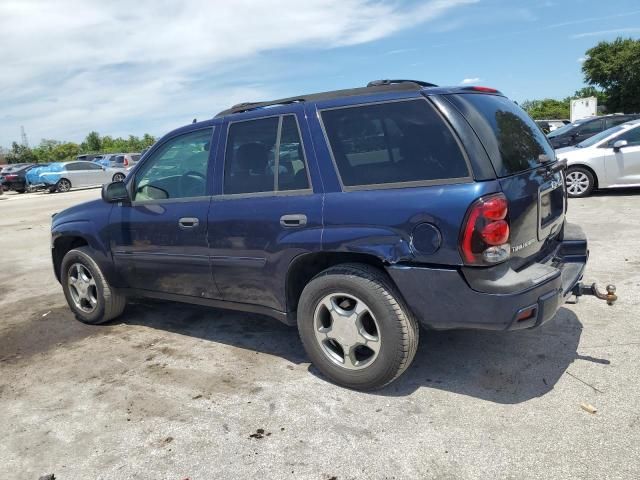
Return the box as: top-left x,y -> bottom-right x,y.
556,120 -> 640,197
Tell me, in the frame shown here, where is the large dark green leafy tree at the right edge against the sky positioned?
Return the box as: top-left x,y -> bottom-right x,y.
582,37 -> 640,113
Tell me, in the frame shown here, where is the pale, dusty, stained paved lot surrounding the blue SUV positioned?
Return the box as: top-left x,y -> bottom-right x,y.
0,189 -> 640,480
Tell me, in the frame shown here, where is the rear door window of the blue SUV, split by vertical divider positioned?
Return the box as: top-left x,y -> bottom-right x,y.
223,115 -> 309,195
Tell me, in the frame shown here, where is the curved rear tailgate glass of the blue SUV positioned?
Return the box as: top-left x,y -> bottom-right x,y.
451,94 -> 557,177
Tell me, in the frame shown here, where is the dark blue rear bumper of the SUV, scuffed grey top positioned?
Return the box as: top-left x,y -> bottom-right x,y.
387,224 -> 589,330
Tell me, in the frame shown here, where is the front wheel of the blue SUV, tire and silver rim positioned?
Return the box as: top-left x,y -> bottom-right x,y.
60,247 -> 126,325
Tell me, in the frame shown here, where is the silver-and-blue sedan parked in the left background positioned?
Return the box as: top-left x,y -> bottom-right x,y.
39,161 -> 123,192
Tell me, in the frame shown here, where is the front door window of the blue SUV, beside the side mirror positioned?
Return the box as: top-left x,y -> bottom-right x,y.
133,128 -> 213,201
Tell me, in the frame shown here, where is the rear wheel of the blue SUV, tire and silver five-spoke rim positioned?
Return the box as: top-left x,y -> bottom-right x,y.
297,263 -> 419,390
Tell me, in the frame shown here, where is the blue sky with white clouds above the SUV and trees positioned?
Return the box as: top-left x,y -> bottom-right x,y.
0,0 -> 640,147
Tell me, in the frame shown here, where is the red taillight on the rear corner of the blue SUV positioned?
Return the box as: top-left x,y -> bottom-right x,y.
460,193 -> 511,265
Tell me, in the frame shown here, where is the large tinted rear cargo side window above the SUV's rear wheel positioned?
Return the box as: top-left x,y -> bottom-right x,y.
321,100 -> 469,187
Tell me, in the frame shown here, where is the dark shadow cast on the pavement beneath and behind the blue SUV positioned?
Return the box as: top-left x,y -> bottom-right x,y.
111,301 -> 608,404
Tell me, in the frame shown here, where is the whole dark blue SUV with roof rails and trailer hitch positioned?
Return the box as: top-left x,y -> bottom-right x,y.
51,80 -> 615,390
